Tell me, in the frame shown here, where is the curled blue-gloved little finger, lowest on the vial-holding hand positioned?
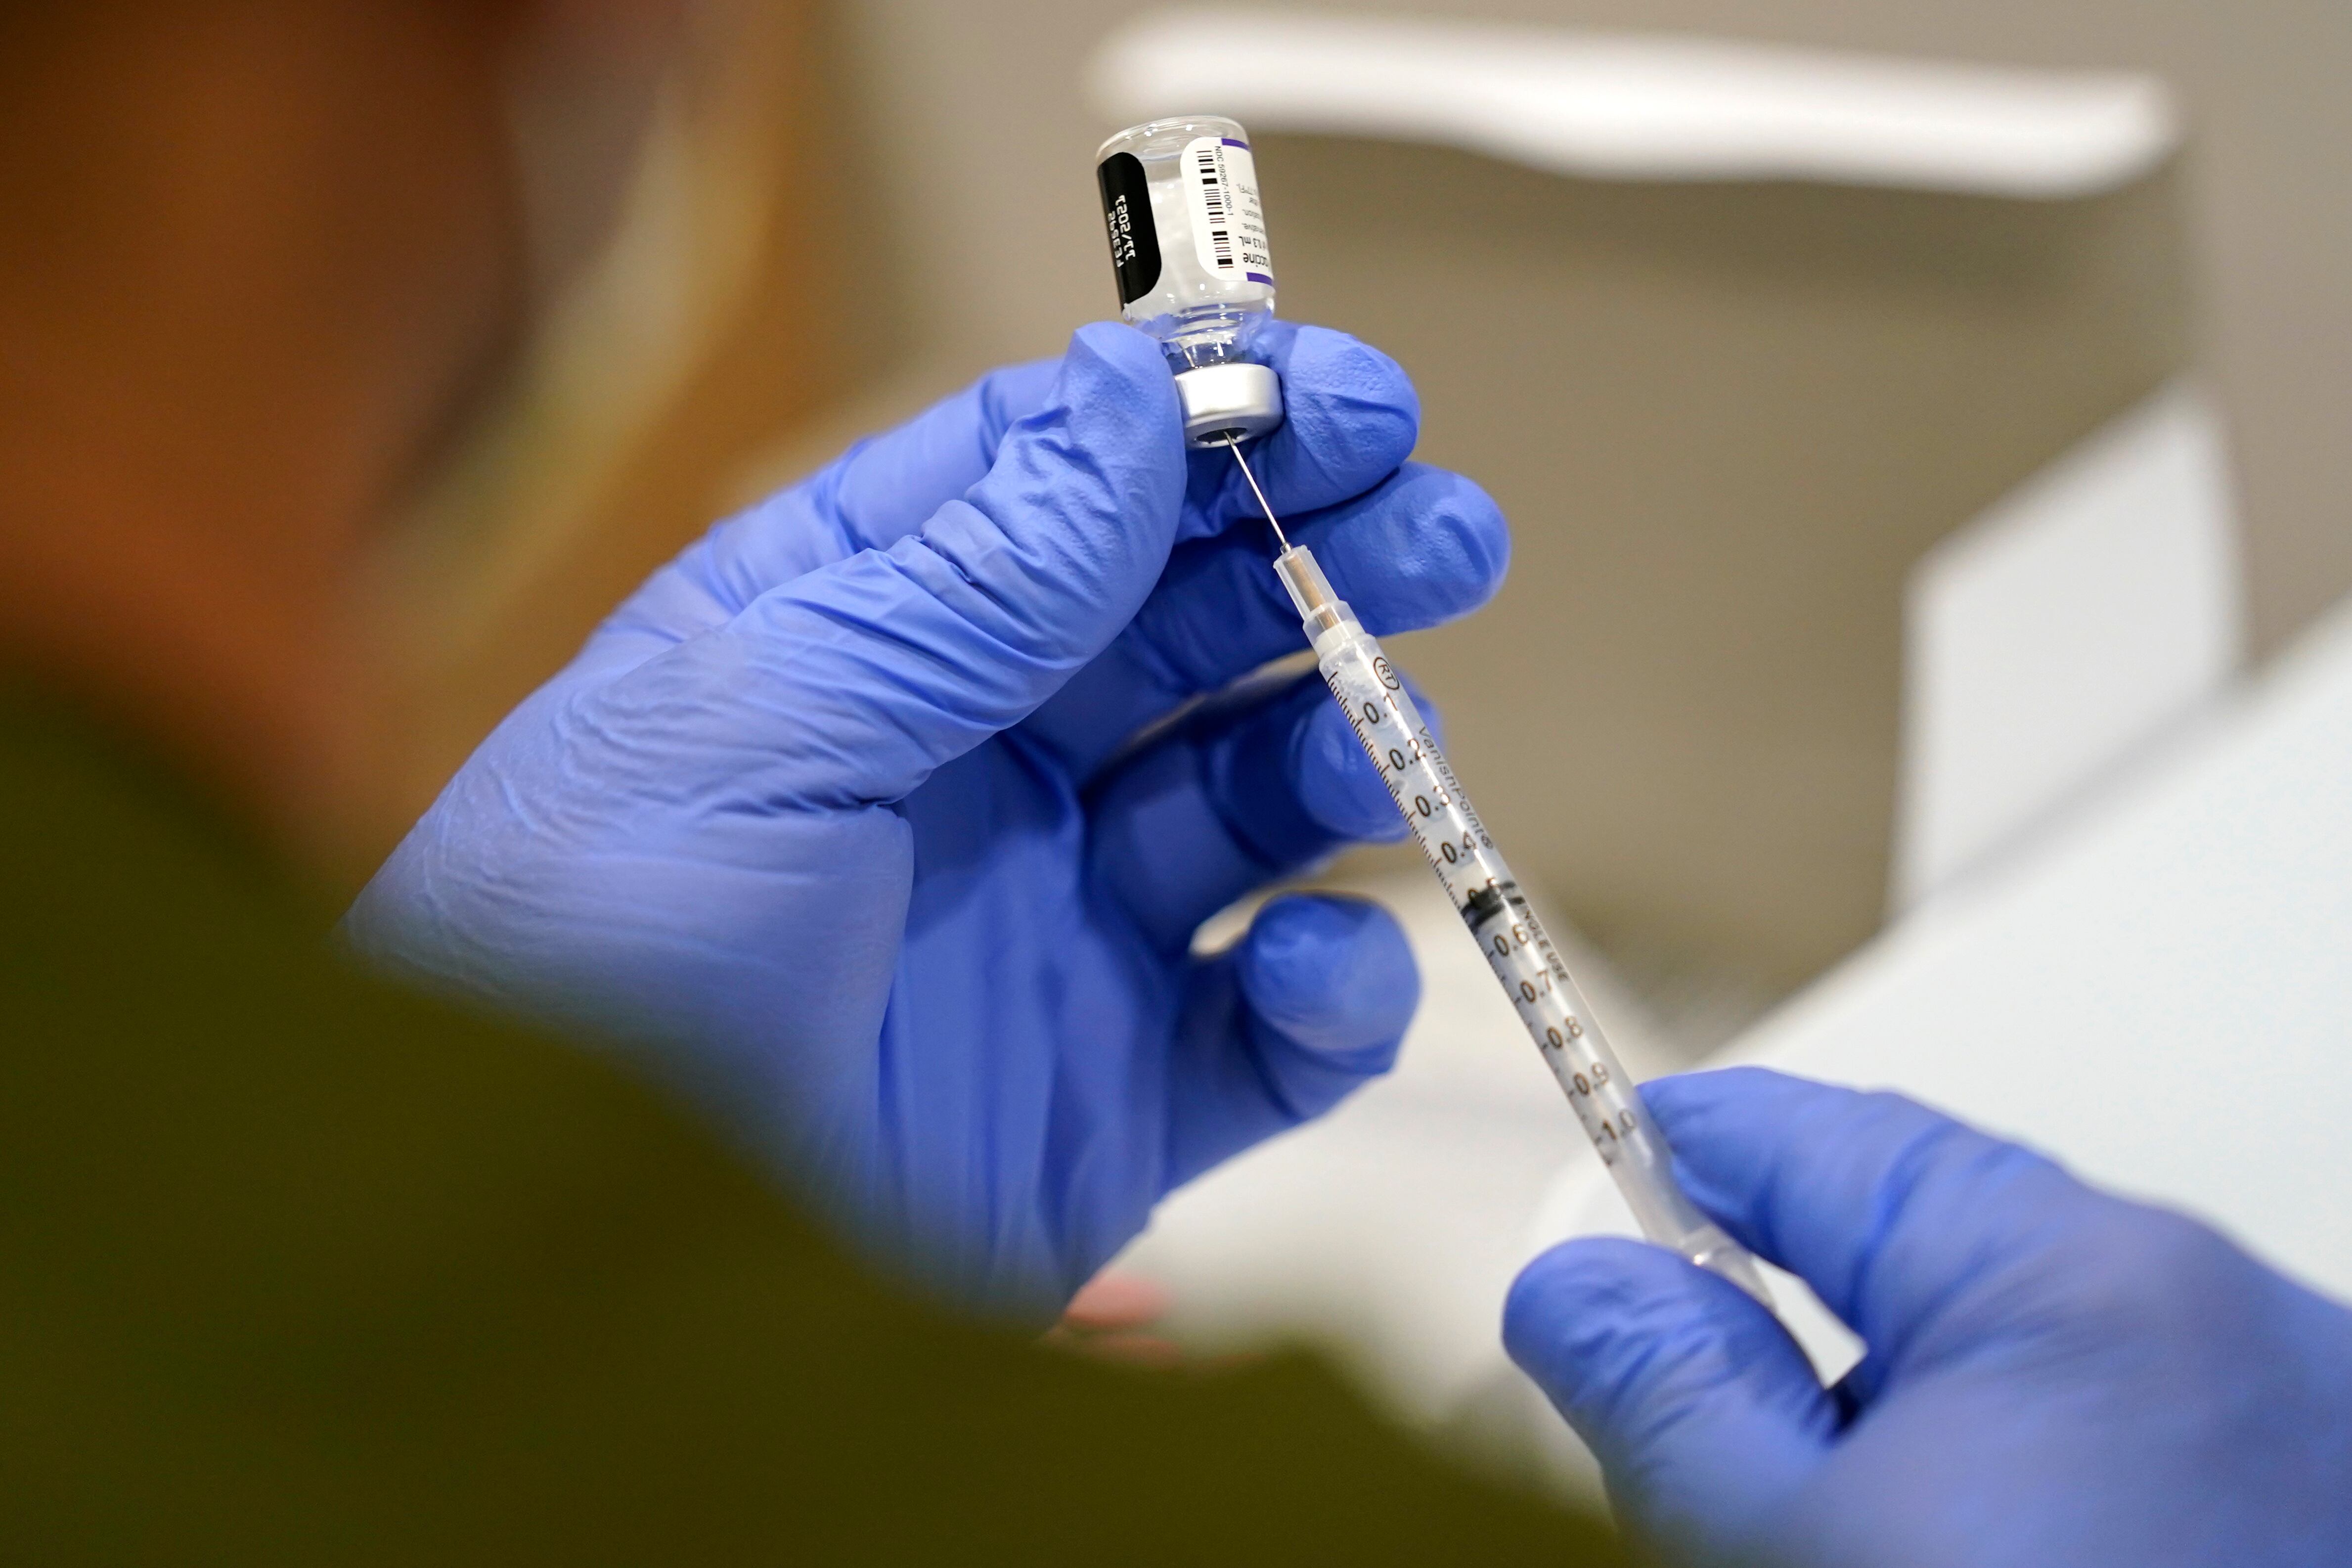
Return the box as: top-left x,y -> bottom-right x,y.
1169,894 -> 1420,1187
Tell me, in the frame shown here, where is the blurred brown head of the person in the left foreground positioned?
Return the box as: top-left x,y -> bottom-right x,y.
0,0 -> 715,860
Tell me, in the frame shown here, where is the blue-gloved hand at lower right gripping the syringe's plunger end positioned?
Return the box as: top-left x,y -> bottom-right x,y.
1505,1067 -> 2352,1568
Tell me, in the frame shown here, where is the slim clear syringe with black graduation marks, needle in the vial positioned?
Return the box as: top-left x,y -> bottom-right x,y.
1225,440 -> 1774,1307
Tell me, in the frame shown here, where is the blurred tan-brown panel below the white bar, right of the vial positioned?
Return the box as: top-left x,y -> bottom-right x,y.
1258,136 -> 2187,987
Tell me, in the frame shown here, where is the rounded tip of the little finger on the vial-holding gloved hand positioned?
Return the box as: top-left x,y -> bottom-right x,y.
1237,894 -> 1420,1072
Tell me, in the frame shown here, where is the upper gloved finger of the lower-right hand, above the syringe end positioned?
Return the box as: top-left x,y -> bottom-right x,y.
1642,1067 -> 2110,1382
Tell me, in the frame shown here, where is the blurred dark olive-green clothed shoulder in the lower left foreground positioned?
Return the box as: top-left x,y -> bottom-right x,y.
0,708 -> 1616,1566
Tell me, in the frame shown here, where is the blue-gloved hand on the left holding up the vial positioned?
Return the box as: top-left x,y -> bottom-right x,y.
346,324 -> 1508,1314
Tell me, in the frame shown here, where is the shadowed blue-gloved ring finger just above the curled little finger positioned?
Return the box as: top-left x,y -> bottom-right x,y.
1087,674 -> 1437,952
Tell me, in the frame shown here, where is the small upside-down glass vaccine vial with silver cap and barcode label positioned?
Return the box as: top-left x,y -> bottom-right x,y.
1094,115 -> 1282,447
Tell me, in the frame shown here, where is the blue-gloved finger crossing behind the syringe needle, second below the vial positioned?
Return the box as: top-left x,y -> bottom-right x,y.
1023,463 -> 1510,776
